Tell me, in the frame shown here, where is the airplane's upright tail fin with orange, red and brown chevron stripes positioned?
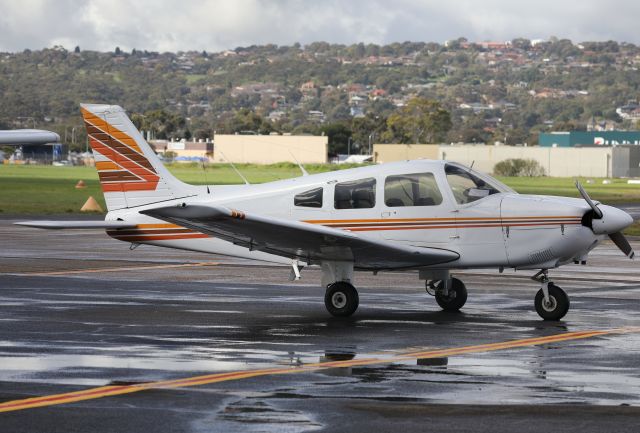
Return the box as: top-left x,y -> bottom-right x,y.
81,104 -> 196,211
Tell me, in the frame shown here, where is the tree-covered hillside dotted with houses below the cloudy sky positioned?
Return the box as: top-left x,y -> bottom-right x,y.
0,38 -> 640,151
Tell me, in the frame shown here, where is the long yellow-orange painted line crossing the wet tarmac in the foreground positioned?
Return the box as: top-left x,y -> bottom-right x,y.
0,327 -> 640,412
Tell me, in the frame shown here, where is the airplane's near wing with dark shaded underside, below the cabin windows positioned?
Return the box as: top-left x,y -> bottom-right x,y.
140,205 -> 460,269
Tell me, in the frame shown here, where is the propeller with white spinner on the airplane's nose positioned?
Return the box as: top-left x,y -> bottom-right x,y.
576,180 -> 635,259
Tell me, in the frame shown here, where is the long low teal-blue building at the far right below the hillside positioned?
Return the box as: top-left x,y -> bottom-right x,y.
538,131 -> 640,147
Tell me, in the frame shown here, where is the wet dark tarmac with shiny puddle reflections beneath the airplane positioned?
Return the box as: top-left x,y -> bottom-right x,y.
0,219 -> 640,433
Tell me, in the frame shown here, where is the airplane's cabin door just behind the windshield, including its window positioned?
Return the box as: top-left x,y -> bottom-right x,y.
380,173 -> 457,248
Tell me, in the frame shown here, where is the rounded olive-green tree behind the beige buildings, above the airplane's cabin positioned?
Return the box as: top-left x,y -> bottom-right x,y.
383,97 -> 452,144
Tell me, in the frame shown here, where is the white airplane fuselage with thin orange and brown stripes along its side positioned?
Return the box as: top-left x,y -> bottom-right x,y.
107,160 -> 603,269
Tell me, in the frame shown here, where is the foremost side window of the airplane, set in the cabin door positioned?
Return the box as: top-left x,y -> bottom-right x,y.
384,173 -> 442,207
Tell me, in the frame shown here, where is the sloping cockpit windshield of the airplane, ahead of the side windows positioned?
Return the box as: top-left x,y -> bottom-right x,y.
444,163 -> 515,204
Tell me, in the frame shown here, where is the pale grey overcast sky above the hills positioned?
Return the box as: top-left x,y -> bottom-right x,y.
0,0 -> 640,52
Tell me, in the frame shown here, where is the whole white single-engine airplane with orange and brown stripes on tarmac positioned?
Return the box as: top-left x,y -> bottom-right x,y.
18,104 -> 634,320
